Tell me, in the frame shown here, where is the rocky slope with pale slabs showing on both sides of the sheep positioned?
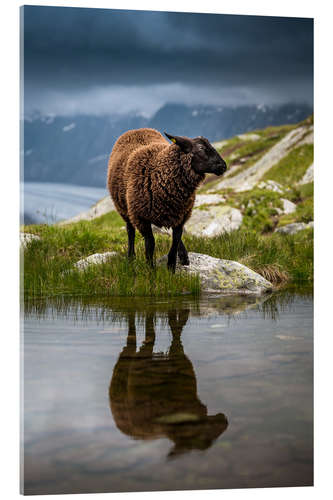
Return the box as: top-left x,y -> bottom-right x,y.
61,117 -> 314,237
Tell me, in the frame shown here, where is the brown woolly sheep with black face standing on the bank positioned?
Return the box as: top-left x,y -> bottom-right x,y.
107,128 -> 227,272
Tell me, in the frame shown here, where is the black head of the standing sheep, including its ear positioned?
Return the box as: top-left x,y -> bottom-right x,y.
165,133 -> 227,175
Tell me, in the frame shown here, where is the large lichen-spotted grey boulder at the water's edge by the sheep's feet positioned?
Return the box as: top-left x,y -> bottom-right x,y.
159,252 -> 273,295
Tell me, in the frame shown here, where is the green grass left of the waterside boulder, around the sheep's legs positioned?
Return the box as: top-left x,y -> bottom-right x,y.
23,212 -> 200,297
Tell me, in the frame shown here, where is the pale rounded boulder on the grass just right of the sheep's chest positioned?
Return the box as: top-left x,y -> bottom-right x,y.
185,206 -> 243,237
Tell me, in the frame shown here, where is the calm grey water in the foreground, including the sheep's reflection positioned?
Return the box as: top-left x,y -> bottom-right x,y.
22,293 -> 313,494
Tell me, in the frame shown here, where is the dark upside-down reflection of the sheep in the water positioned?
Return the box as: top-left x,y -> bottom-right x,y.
109,309 -> 228,457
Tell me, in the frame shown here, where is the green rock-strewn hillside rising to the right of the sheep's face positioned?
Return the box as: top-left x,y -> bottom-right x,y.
193,116 -> 314,233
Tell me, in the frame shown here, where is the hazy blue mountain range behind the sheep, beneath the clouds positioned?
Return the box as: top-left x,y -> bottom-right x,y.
21,103 -> 312,187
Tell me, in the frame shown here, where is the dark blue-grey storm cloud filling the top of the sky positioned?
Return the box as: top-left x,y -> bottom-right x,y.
24,7 -> 313,114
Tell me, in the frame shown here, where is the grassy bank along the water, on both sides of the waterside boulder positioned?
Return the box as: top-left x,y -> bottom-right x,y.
22,212 -> 313,297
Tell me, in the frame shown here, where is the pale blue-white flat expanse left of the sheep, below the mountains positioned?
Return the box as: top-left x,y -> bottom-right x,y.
20,182 -> 107,224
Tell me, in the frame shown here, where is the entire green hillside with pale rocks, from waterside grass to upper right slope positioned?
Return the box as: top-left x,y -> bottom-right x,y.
22,116 -> 313,297
